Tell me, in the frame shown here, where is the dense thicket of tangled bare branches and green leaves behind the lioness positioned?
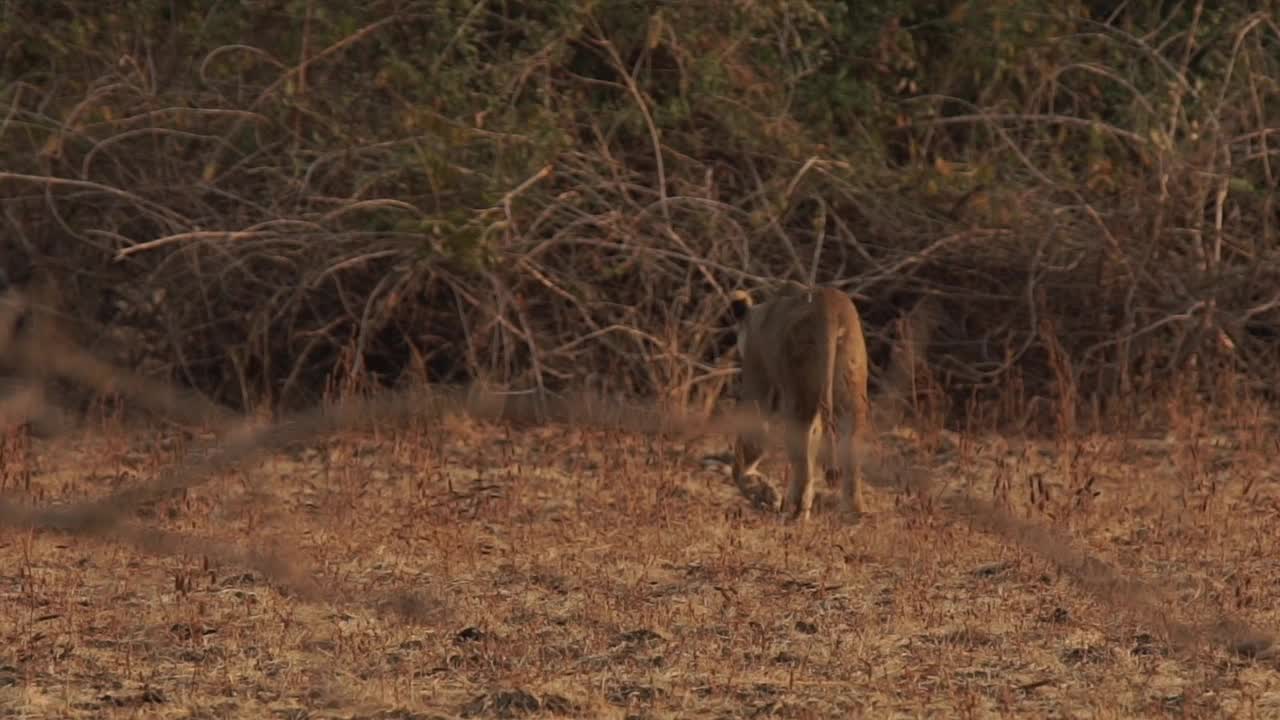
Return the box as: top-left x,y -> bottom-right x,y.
0,0 -> 1280,422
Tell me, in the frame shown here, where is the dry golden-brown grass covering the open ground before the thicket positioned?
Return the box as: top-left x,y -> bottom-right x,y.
0,407 -> 1280,719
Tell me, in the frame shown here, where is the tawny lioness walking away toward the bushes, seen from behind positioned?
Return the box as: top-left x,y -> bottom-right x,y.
730,288 -> 869,520
